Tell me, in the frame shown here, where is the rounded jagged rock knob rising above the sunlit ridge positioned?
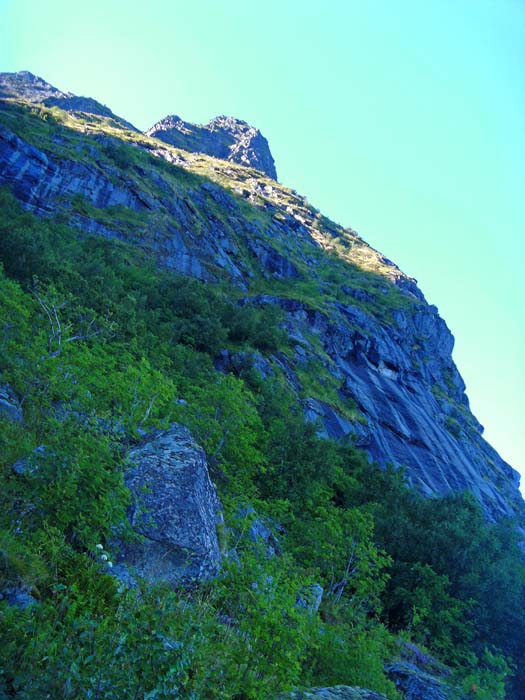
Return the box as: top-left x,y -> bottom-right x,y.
146,114 -> 277,180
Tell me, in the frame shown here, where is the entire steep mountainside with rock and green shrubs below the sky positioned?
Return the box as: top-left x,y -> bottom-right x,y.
0,72 -> 525,700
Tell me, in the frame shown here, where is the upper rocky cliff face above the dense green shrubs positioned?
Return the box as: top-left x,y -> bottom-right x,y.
0,74 -> 524,521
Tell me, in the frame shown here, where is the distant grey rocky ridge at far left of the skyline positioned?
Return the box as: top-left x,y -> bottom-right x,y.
0,70 -> 137,131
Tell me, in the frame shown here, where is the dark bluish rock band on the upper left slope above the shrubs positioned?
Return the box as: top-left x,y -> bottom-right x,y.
0,126 -> 258,289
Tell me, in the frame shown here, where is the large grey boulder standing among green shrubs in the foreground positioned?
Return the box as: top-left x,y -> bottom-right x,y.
113,424 -> 221,584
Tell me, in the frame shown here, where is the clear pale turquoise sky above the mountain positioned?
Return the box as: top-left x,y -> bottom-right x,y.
0,0 -> 525,492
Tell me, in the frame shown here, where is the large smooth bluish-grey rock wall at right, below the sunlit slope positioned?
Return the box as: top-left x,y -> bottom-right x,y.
244,295 -> 523,520
